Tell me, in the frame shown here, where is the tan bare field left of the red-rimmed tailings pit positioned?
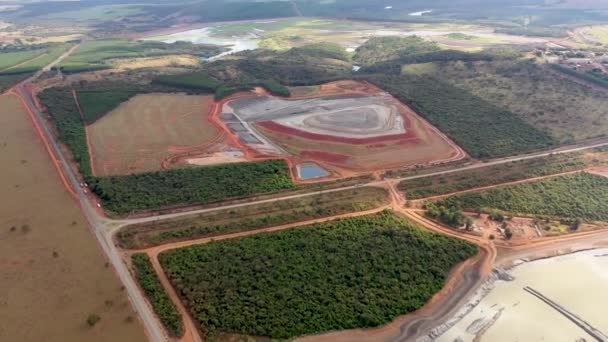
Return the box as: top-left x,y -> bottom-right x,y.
88,94 -> 226,176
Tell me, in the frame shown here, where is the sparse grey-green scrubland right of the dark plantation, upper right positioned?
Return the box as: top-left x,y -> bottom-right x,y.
405,60 -> 608,143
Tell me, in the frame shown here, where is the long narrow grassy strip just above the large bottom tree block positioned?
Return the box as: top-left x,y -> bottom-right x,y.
117,187 -> 388,249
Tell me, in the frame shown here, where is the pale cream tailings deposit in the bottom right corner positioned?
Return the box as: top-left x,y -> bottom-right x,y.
432,249 -> 608,342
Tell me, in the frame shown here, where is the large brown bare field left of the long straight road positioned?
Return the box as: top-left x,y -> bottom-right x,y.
0,96 -> 146,342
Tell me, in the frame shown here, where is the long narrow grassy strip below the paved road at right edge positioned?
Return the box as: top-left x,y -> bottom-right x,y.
399,151 -> 608,200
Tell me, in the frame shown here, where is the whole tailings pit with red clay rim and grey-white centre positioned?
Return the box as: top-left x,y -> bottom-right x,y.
223,81 -> 464,172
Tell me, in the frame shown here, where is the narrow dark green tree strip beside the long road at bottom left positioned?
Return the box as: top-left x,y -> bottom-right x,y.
131,253 -> 184,337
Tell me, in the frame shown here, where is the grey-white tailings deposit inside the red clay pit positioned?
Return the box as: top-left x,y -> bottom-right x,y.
228,96 -> 406,139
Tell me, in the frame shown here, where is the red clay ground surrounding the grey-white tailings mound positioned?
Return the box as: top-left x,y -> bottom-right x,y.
216,81 -> 466,177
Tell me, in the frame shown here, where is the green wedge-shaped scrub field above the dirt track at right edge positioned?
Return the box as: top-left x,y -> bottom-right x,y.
437,173 -> 608,221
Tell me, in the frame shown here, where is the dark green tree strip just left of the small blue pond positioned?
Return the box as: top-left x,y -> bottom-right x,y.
91,159 -> 295,214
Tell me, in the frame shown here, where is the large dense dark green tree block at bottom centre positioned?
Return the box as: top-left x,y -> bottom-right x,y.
159,211 -> 477,339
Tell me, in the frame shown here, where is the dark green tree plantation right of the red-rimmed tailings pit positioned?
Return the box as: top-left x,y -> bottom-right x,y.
365,75 -> 554,159
